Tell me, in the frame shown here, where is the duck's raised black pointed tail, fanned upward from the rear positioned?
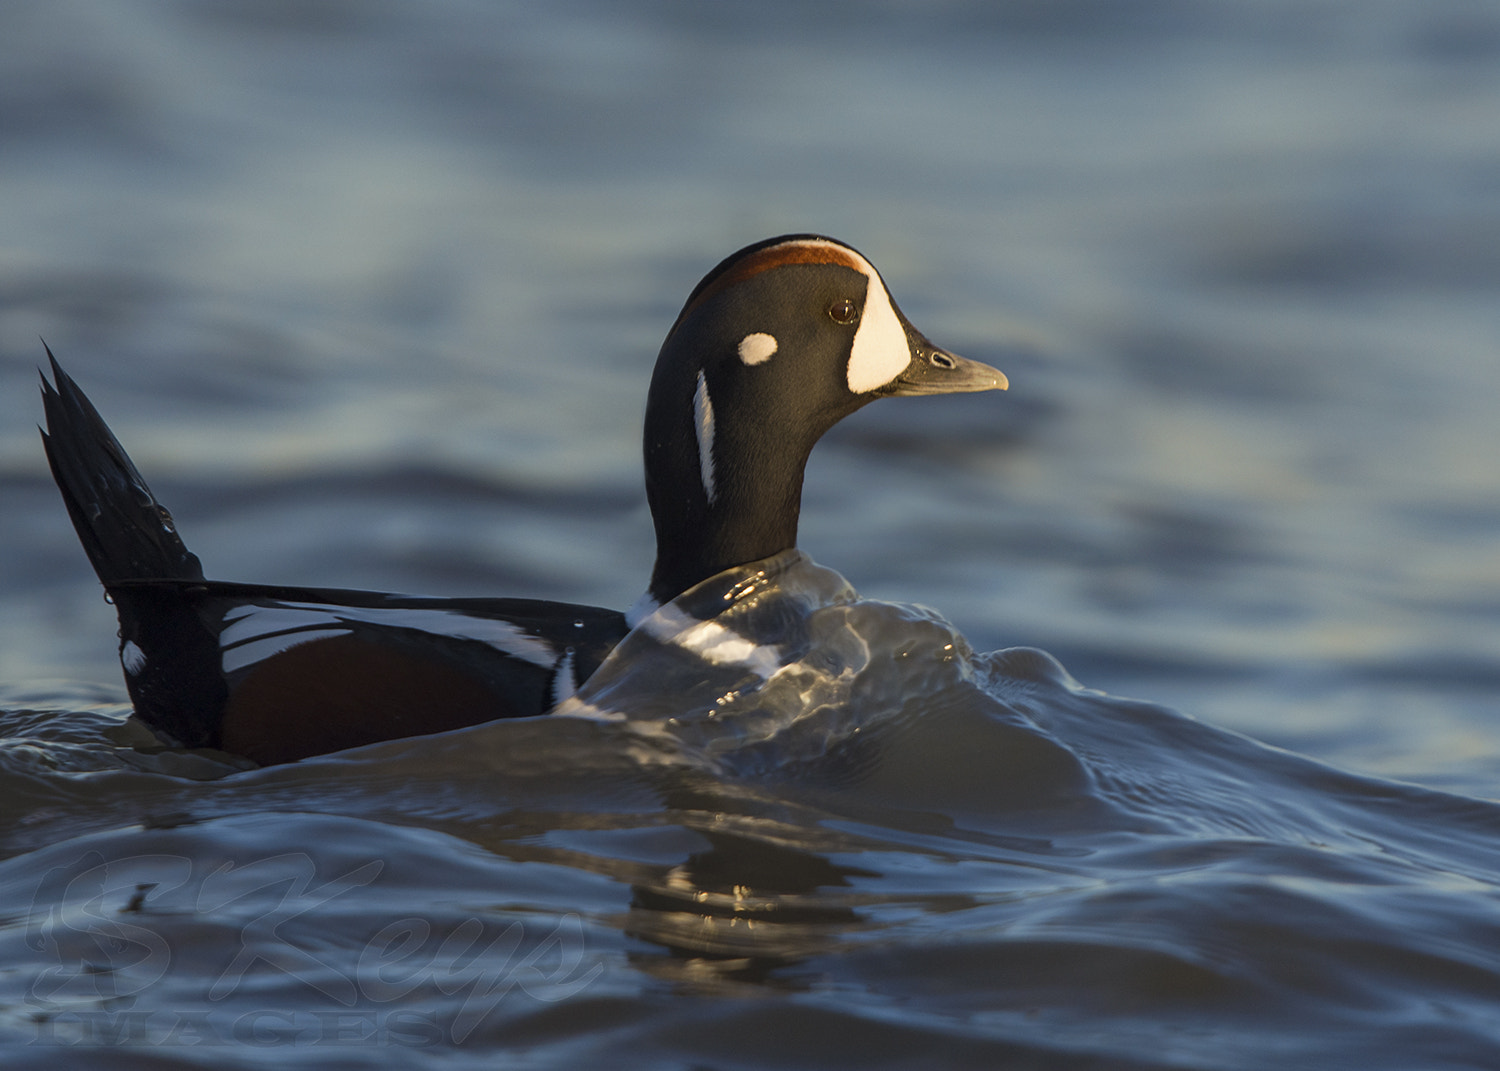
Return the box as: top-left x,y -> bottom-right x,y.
42,342 -> 203,588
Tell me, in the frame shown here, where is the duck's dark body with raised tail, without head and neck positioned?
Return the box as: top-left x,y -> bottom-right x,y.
33,344 -> 627,762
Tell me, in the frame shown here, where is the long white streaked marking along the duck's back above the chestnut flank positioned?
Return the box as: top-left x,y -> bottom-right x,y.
219,603 -> 558,672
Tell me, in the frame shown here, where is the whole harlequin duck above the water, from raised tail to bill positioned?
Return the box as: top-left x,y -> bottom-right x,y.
42,234 -> 1007,764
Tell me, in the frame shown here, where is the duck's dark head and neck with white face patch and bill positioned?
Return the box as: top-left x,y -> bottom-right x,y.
644,234 -> 1007,605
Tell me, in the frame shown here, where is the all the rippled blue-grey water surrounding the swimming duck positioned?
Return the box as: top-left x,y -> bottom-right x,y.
0,0 -> 1500,1070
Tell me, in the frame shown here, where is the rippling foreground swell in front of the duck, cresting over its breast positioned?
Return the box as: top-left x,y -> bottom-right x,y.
0,552 -> 1500,1068
